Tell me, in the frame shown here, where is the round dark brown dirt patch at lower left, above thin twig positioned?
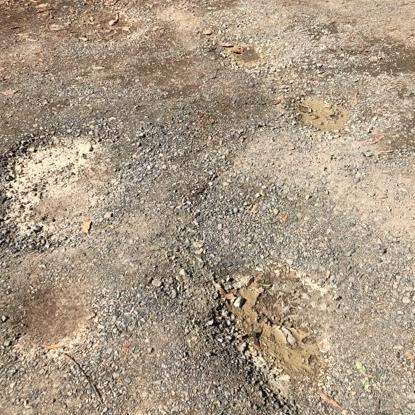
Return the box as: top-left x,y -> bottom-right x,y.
19,285 -> 89,349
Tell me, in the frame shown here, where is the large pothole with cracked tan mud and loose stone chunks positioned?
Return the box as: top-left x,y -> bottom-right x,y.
217,264 -> 330,390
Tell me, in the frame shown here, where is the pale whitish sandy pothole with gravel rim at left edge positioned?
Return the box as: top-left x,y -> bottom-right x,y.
4,137 -> 114,247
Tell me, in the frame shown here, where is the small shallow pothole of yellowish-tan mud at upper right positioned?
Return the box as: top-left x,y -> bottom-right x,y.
298,97 -> 350,131
